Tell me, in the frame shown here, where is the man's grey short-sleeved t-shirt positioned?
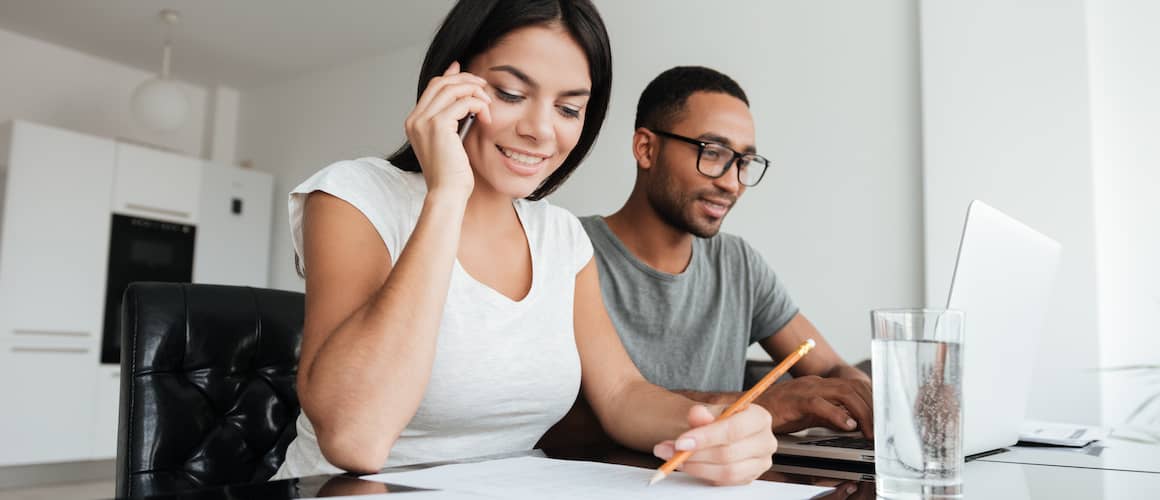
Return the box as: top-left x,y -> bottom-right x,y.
580,216 -> 798,391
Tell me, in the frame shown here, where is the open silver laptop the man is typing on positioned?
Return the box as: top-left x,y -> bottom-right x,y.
777,201 -> 1060,462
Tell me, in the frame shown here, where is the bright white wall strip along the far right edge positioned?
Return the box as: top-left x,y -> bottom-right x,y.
1088,0 -> 1160,425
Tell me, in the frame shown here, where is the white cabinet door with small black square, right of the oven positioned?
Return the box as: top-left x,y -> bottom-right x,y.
194,164 -> 274,288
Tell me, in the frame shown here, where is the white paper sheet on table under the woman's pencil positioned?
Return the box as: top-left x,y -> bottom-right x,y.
362,457 -> 832,500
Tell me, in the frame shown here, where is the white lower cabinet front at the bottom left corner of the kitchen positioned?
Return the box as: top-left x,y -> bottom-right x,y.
0,339 -> 96,466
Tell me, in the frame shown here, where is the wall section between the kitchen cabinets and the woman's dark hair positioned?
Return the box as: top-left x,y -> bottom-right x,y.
238,44 -> 435,291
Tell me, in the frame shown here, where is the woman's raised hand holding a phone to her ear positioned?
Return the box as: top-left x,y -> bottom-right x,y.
404,61 -> 492,198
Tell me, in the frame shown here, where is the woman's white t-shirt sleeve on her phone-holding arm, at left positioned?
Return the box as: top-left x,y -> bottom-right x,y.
288,160 -> 414,269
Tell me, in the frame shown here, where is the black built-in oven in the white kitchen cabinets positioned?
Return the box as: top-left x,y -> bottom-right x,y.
101,213 -> 197,364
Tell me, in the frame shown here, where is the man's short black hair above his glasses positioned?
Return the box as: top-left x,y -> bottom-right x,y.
632,66 -> 749,130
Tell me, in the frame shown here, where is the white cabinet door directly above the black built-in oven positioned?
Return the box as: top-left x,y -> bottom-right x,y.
113,143 -> 202,224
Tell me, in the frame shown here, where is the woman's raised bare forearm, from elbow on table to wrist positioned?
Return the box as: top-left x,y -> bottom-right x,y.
298,194 -> 466,471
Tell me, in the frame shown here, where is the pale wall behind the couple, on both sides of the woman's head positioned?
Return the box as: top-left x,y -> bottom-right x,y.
239,0 -> 922,368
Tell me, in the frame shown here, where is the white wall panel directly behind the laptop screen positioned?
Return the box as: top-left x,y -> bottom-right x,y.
921,0 -> 1100,423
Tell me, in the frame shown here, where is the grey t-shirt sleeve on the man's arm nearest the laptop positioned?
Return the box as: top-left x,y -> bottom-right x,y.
741,240 -> 798,343
